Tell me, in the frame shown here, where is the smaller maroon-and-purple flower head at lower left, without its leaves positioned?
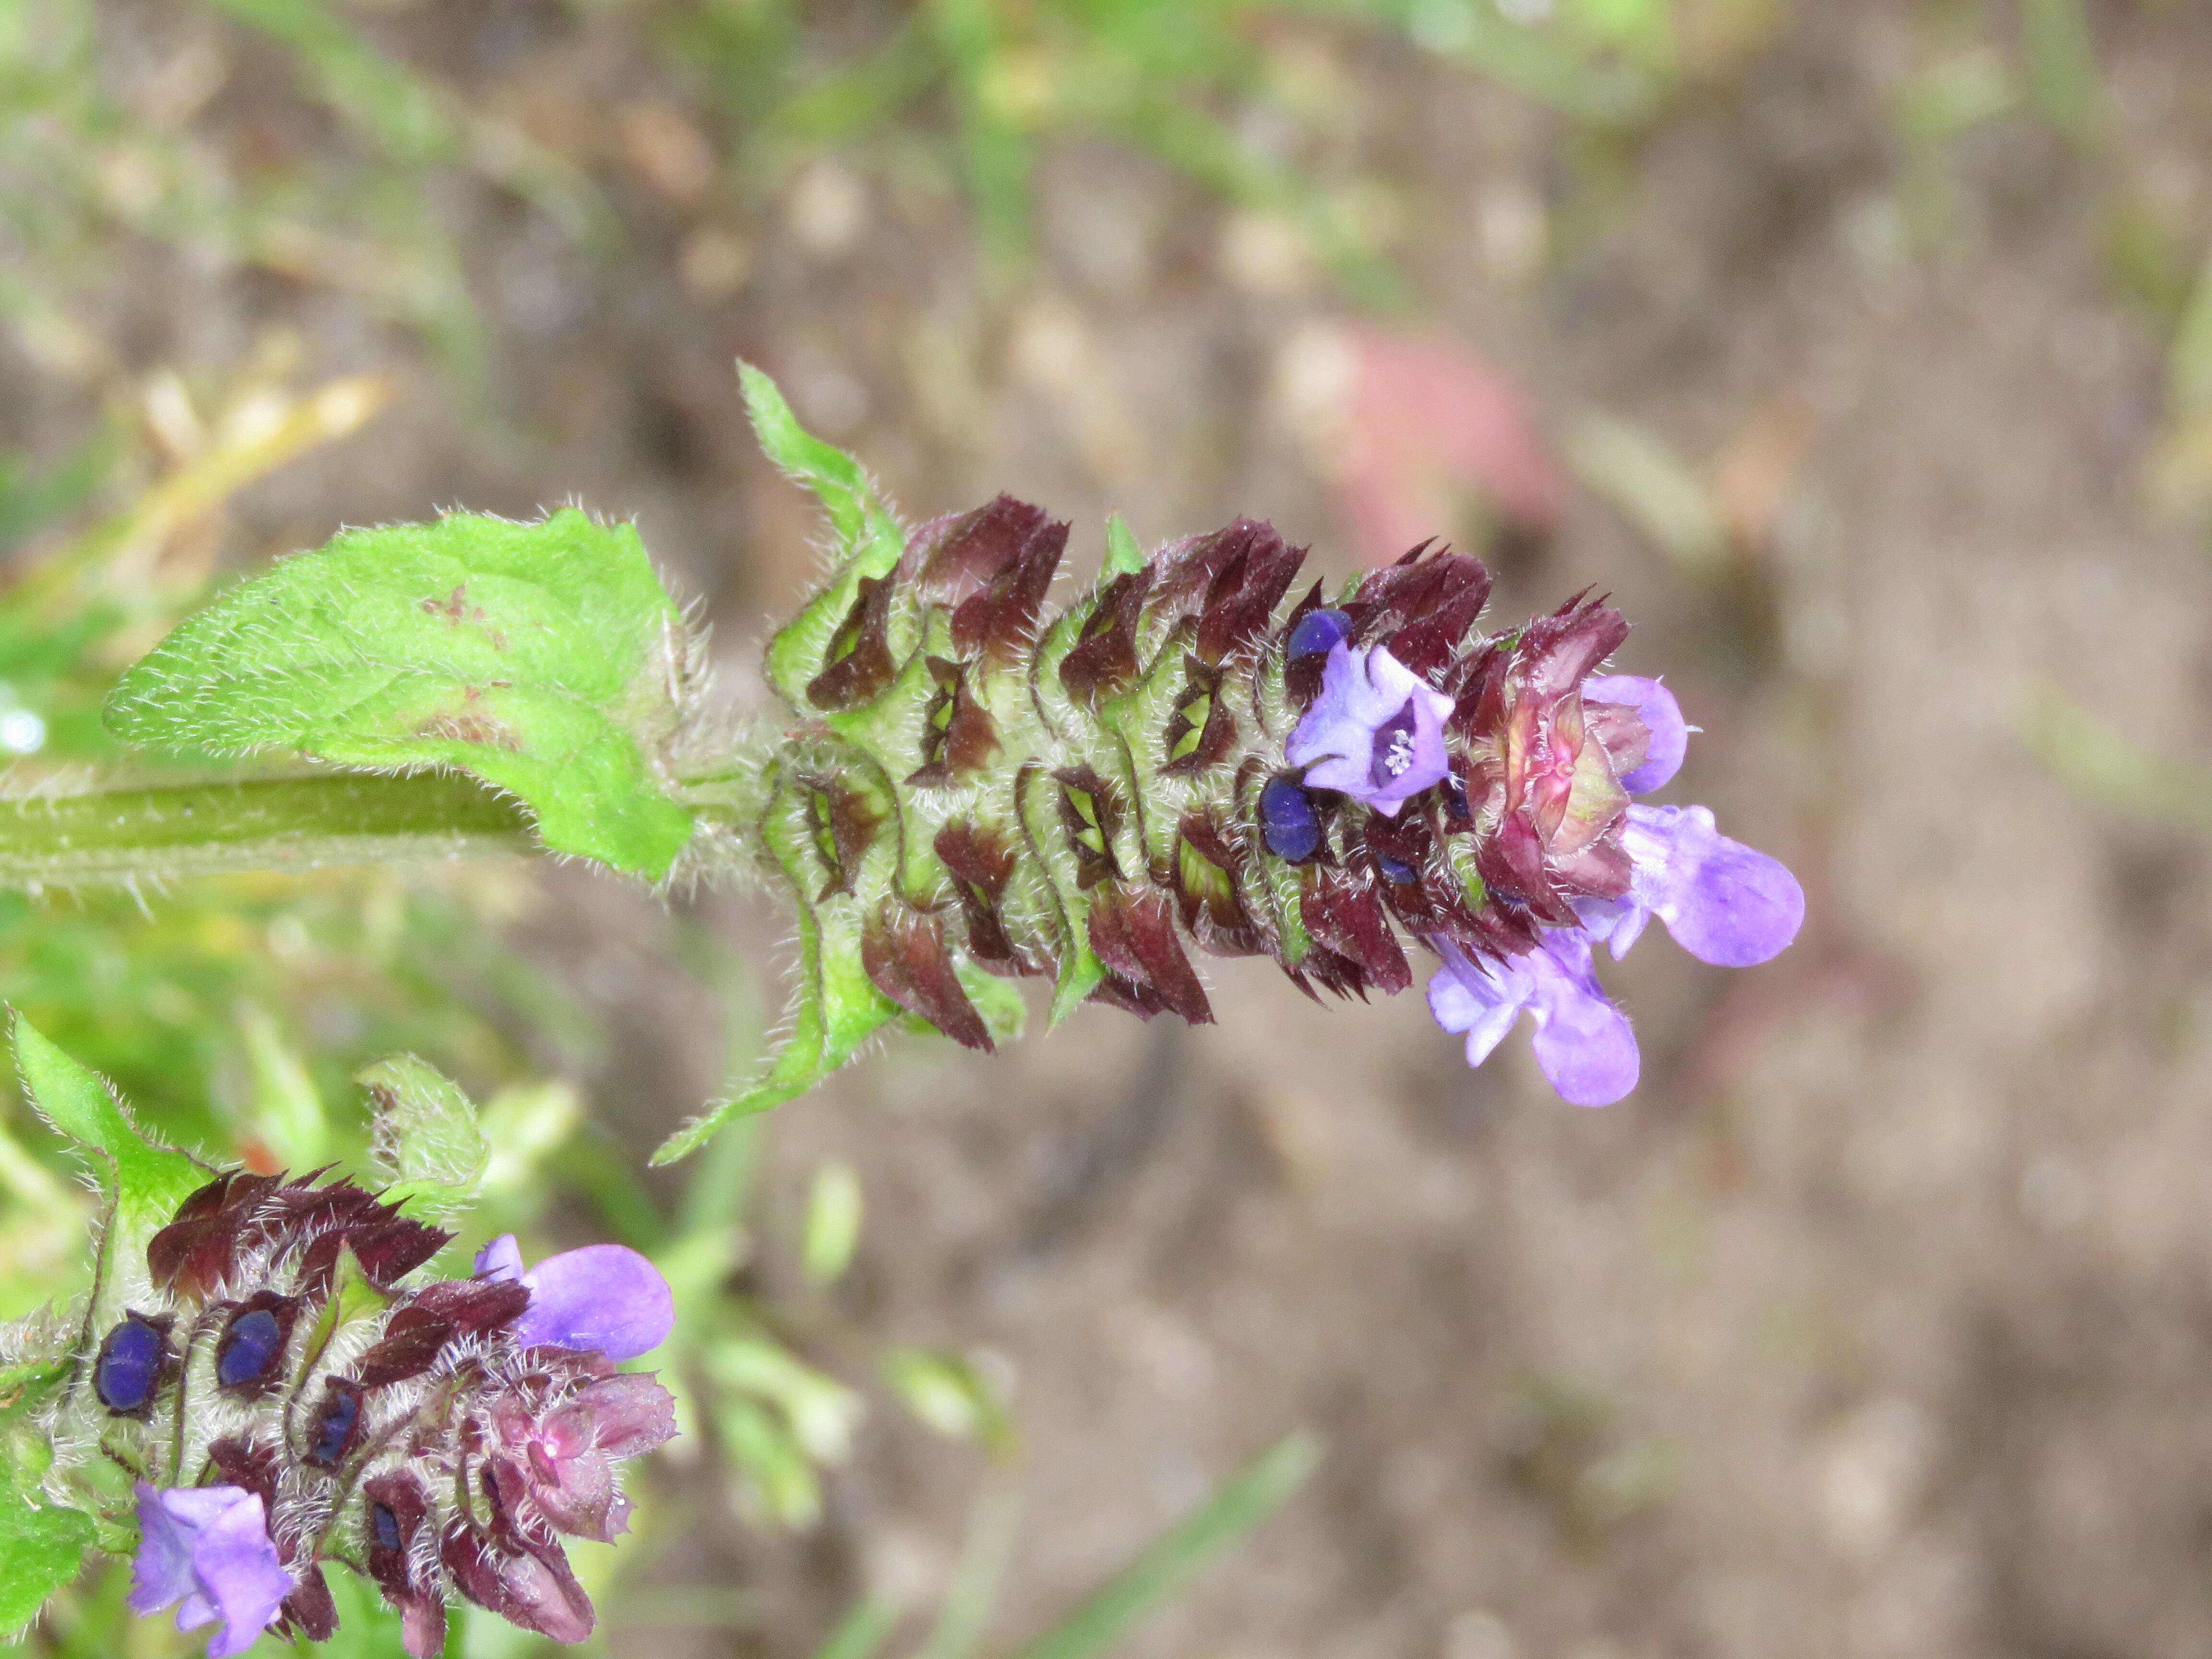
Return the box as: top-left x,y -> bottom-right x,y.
82,1172 -> 674,1659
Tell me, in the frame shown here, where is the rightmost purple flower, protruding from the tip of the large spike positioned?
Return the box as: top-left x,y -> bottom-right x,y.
1575,805 -> 1805,967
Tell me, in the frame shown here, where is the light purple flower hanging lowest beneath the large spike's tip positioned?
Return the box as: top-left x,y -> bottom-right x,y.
1429,929 -> 1639,1106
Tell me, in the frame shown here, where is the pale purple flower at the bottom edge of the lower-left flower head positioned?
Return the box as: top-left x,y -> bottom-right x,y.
128,1480 -> 292,1659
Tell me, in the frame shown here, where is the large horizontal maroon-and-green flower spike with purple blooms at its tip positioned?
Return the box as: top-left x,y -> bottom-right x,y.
750,480 -> 1803,1106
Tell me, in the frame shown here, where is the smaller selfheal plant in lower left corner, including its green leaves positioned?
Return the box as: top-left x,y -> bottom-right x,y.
0,1020 -> 674,1659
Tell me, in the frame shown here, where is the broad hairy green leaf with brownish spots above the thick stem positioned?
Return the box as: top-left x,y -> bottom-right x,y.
106,509 -> 692,878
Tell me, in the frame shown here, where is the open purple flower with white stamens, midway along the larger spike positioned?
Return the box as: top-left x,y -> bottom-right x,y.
1287,641 -> 1451,818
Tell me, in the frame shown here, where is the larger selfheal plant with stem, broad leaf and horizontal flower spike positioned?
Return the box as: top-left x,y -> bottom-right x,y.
0,367 -> 1803,1159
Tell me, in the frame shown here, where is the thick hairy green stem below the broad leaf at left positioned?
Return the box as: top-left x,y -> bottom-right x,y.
0,772 -> 538,891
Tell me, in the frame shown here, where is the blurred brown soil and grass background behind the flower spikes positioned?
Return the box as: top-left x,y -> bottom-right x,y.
0,0 -> 2212,1659
